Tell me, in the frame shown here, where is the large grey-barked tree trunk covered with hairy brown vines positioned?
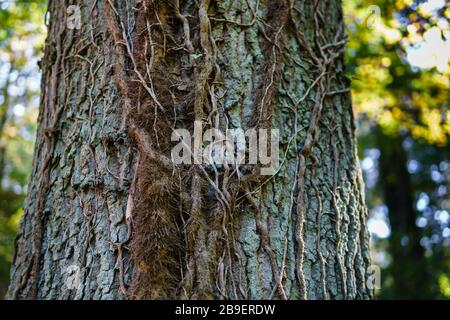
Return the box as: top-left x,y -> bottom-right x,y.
8,0 -> 372,299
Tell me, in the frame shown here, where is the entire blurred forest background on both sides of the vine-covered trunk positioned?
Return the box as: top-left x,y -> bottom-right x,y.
0,0 -> 450,299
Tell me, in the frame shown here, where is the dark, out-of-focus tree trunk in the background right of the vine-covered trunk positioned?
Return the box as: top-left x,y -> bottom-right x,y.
377,129 -> 432,299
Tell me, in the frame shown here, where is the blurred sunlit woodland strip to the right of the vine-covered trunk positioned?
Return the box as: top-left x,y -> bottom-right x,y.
345,0 -> 450,299
